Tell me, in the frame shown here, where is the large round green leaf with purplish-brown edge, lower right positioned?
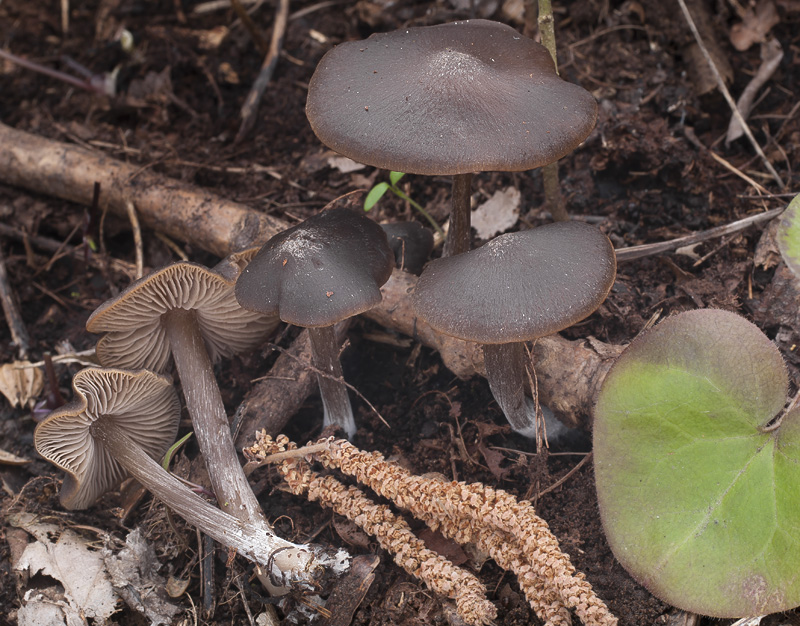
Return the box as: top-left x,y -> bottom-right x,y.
594,309 -> 800,618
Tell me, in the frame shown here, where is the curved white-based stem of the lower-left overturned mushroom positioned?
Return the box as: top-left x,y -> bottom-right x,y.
91,417 -> 324,584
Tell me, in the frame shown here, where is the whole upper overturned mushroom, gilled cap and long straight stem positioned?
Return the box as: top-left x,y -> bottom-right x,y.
86,250 -> 312,592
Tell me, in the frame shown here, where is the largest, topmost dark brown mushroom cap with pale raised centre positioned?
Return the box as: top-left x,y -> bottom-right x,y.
306,20 -> 597,175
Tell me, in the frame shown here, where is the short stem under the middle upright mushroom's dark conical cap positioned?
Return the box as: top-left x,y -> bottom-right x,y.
308,326 -> 356,439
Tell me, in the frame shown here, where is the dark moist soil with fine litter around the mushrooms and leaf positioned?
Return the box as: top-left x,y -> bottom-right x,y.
0,0 -> 800,626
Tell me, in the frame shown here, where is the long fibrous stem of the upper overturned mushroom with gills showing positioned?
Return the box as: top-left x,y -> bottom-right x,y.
163,309 -> 324,582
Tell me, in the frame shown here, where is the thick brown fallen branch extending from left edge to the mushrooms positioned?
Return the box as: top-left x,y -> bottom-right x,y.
0,123 -> 287,257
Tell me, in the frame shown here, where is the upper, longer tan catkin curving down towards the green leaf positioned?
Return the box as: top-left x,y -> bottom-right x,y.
314,440 -> 617,626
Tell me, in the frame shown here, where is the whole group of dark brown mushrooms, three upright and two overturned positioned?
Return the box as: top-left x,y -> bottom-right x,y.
35,20 -> 616,592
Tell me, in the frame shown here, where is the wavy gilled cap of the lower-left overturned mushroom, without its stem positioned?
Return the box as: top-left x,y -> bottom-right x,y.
34,368 -> 181,509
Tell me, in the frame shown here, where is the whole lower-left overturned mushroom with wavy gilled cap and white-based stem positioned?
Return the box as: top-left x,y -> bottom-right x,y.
34,368 -> 344,583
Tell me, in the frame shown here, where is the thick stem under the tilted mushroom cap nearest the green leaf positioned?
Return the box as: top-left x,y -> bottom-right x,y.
483,342 -> 536,438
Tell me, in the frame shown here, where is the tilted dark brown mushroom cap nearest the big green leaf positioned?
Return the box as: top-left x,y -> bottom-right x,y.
412,222 -> 616,344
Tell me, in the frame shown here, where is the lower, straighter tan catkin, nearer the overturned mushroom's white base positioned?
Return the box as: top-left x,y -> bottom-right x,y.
250,434 -> 497,626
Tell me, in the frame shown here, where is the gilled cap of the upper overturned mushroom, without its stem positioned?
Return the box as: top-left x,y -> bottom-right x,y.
86,252 -> 278,372
